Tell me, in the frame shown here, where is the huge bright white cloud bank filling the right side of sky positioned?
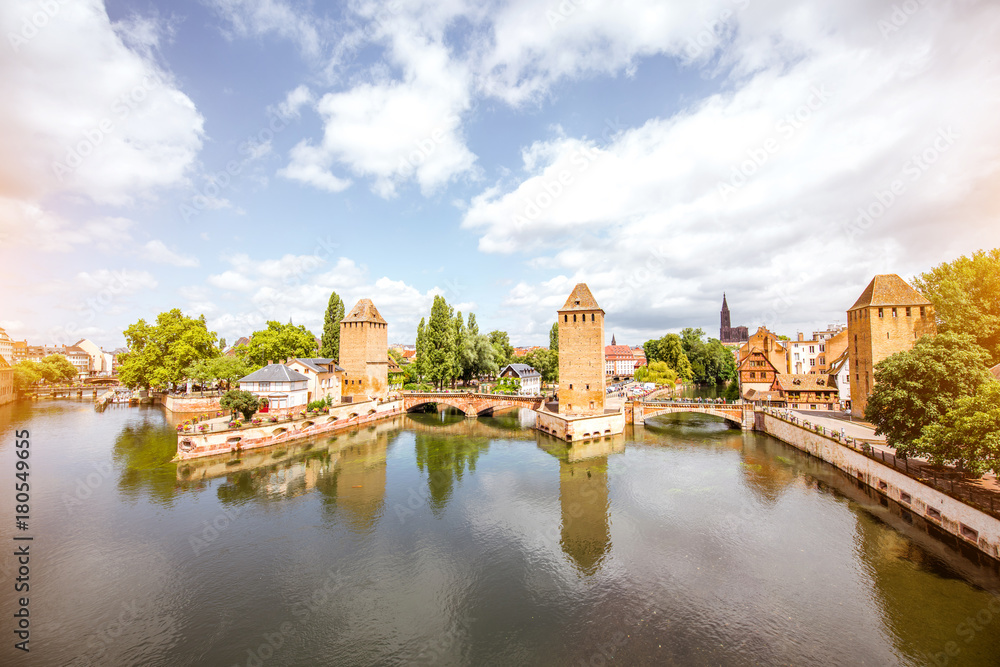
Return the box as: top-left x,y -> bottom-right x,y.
462,3 -> 1000,337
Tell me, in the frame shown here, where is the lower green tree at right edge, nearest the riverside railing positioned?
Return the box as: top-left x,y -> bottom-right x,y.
914,379 -> 1000,475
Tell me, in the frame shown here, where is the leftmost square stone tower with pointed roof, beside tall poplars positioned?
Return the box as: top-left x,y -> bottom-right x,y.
340,299 -> 389,399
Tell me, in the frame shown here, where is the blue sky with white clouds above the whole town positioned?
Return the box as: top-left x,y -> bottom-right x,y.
0,0 -> 1000,349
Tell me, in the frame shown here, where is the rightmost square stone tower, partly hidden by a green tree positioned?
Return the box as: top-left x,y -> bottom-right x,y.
847,273 -> 937,417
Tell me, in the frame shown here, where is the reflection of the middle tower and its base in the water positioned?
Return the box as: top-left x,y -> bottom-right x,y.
538,435 -> 625,576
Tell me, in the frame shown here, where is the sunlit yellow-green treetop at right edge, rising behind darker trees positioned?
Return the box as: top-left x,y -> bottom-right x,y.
913,248 -> 1000,364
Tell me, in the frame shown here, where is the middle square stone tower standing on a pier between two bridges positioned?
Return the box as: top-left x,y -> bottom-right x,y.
558,283 -> 606,415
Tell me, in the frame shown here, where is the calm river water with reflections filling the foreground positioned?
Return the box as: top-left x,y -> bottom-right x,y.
0,400 -> 1000,667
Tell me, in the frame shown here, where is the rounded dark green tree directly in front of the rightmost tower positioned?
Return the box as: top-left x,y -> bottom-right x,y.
865,333 -> 992,456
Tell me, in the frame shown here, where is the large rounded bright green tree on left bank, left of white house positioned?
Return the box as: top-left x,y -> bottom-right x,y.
118,308 -> 219,389
